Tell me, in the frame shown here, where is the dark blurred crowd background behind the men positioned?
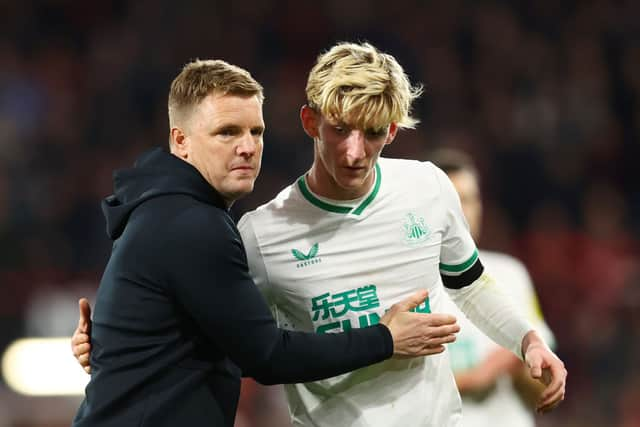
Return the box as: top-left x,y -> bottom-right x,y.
0,0 -> 640,427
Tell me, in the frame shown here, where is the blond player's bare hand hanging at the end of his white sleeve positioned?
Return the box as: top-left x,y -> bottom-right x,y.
522,331 -> 567,413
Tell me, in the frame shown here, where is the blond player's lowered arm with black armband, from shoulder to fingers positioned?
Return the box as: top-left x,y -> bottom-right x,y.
436,169 -> 567,412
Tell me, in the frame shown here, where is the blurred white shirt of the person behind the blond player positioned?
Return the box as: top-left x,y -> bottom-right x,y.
448,250 -> 553,427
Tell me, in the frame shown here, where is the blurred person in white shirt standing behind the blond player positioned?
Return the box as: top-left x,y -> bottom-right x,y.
427,149 -> 554,427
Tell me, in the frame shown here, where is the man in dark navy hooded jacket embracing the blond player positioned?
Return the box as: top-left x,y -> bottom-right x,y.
73,61 -> 458,427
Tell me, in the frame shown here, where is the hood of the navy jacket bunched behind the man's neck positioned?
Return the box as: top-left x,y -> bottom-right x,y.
102,148 -> 227,240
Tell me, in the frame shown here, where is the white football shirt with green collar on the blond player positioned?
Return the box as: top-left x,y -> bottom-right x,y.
238,158 -> 478,427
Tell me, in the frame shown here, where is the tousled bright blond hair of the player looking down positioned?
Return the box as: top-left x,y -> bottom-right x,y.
306,43 -> 422,129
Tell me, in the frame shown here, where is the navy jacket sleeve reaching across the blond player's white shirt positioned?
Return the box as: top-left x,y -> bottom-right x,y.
166,208 -> 393,384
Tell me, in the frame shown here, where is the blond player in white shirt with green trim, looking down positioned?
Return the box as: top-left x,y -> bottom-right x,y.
238,43 -> 566,427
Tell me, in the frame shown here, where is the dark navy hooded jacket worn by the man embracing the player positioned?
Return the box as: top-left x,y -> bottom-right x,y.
73,149 -> 393,427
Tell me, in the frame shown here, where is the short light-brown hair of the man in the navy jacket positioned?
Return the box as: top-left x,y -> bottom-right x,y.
168,59 -> 264,127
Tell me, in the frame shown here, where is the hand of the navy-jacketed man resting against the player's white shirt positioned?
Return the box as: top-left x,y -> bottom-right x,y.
380,290 -> 460,357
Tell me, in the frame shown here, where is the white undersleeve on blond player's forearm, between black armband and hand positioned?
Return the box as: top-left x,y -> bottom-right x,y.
447,273 -> 534,359
